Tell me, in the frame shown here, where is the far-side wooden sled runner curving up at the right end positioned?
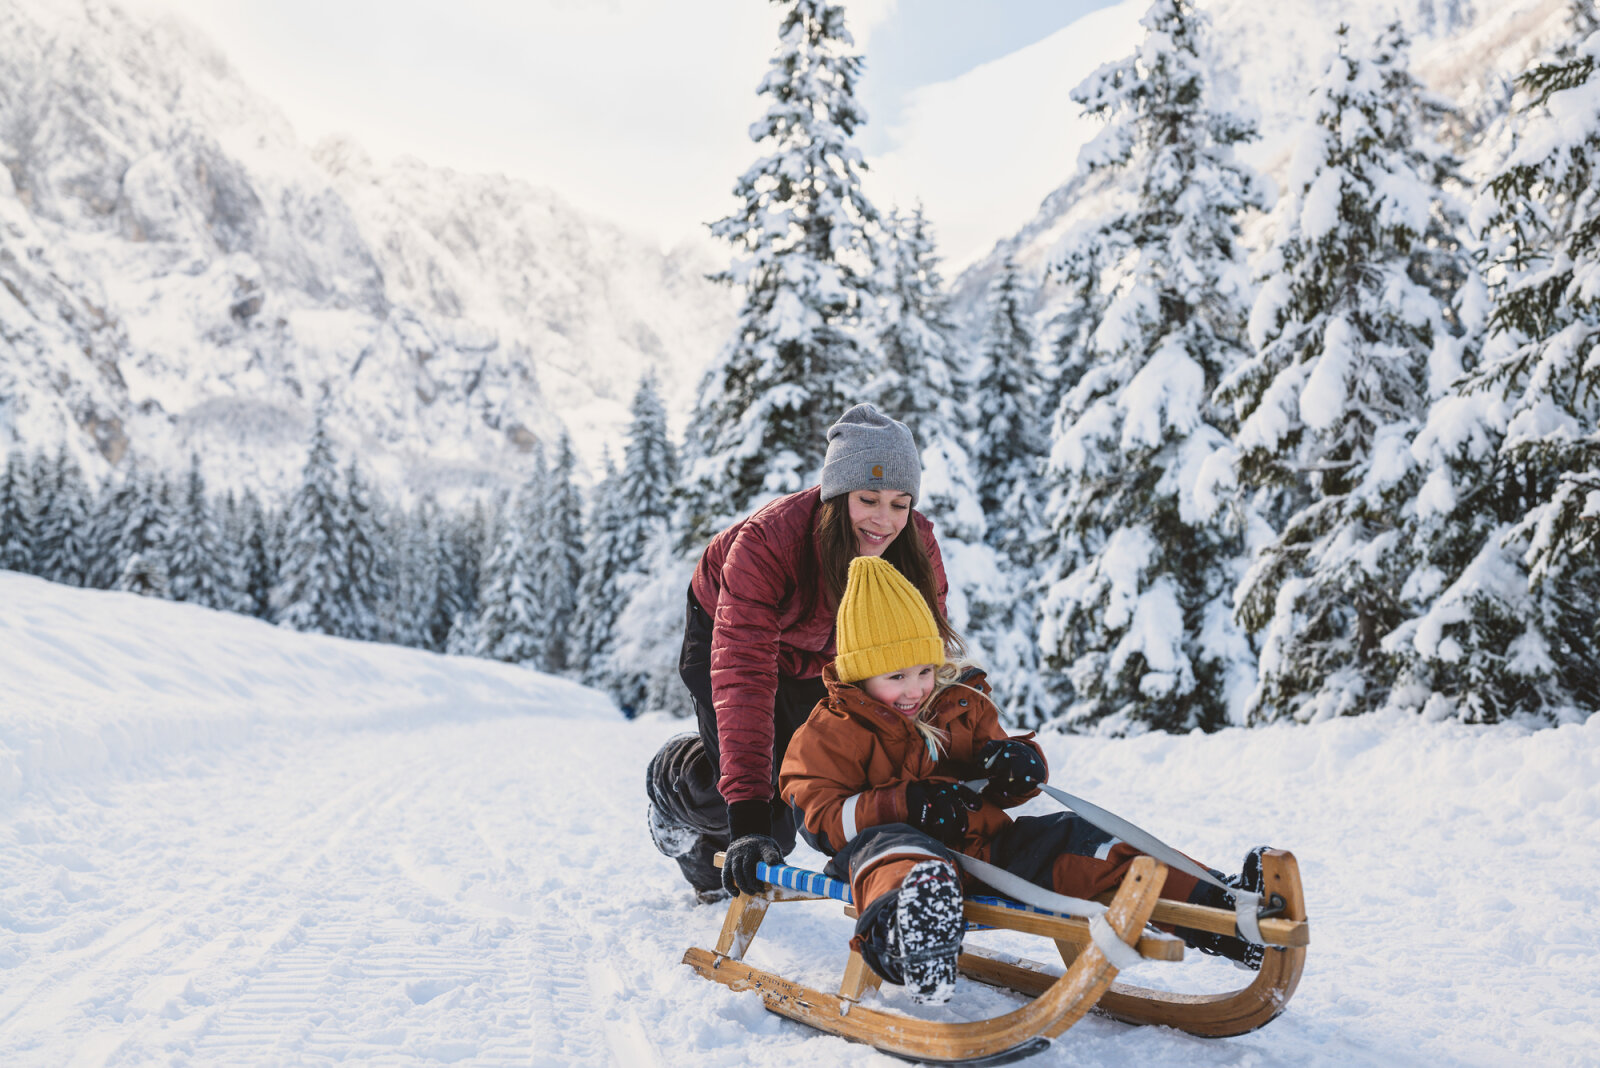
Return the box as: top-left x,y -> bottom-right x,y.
960,849 -> 1309,1038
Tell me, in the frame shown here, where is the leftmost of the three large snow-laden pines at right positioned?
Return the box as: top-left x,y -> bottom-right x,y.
1040,0 -> 1264,732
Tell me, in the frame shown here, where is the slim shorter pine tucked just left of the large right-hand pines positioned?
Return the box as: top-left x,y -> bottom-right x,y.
970,254 -> 1045,571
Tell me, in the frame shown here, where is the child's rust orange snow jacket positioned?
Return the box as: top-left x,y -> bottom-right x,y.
778,664 -> 1045,855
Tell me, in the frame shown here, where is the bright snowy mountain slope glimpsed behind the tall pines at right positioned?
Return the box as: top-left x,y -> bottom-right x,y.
952,0 -> 1568,323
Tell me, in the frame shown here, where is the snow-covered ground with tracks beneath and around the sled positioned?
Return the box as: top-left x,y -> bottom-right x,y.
0,572 -> 1600,1068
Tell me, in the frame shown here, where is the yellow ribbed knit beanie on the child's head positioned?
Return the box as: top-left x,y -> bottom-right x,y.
834,556 -> 944,683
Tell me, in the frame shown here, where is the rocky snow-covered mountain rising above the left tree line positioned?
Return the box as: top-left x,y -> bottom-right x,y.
0,0 -> 734,491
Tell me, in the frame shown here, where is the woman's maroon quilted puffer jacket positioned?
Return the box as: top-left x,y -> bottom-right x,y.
690,486 -> 949,804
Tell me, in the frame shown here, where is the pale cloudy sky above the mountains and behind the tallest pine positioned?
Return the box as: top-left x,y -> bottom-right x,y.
133,0 -> 1112,265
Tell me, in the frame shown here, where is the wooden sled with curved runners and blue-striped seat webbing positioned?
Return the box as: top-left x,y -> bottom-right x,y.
683,849 -> 1310,1063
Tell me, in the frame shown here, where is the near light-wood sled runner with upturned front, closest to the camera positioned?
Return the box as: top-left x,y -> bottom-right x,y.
683,857 -> 1166,1062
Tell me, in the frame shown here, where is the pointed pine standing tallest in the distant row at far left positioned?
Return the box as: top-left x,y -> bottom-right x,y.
272,408 -> 352,635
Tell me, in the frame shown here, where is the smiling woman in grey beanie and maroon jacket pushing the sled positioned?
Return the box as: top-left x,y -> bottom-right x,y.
645,404 -> 955,900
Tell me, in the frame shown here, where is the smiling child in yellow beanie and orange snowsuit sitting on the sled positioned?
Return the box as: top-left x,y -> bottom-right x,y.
779,556 -> 1261,1002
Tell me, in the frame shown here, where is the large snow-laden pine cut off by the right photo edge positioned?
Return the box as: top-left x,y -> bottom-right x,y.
1392,27 -> 1600,723
